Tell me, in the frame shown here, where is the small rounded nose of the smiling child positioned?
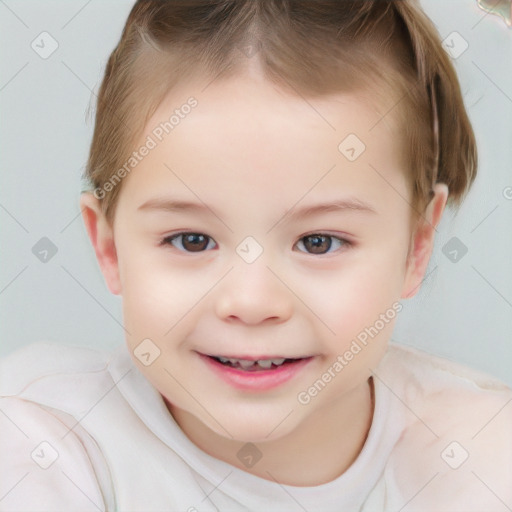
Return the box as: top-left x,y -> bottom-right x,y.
212,258 -> 293,325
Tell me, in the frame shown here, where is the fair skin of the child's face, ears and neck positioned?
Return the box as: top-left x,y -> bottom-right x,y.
81,70 -> 448,486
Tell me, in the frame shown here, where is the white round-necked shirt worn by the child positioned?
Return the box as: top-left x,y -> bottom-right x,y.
0,342 -> 512,512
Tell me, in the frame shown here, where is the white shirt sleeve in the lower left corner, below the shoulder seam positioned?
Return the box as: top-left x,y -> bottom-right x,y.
0,397 -> 115,512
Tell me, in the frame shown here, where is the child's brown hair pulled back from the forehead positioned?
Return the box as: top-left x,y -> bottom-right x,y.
84,0 -> 477,226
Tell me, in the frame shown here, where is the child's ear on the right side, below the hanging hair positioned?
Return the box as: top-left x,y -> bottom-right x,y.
401,183 -> 448,299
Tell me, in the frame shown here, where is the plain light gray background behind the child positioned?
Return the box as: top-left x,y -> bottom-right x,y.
0,0 -> 512,385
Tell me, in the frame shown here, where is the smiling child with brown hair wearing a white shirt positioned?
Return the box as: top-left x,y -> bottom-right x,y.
0,0 -> 512,512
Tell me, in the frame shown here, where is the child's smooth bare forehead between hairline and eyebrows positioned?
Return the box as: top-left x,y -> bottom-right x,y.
119,76 -> 405,219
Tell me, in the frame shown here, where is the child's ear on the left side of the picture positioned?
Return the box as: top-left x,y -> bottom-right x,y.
80,192 -> 121,295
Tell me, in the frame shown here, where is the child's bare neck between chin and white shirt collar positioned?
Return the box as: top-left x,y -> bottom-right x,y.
164,378 -> 374,487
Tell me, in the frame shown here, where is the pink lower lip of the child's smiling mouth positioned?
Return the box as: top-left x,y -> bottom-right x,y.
199,354 -> 314,391
